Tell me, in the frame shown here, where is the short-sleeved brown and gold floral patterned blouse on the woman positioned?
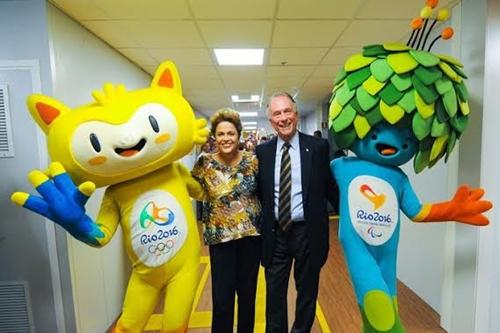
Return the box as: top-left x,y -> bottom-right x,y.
191,151 -> 261,245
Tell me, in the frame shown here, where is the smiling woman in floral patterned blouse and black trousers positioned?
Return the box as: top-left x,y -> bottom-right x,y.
192,108 -> 261,333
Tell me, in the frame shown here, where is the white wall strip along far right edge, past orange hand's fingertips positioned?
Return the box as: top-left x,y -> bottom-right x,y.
474,0 -> 500,333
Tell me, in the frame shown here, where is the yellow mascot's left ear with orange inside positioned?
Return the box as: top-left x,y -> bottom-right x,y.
27,95 -> 70,134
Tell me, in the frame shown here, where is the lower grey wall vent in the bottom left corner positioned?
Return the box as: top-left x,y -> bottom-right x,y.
0,281 -> 35,333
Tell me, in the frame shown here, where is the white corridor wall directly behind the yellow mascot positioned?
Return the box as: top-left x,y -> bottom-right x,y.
48,5 -> 150,333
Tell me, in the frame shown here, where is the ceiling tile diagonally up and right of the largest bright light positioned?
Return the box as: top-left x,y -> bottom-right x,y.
272,20 -> 348,47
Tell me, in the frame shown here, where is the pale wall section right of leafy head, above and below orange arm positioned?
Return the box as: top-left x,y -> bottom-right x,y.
442,0 -> 487,333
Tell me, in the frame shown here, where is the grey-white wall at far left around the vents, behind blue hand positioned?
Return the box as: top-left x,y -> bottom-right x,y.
0,0 -> 64,332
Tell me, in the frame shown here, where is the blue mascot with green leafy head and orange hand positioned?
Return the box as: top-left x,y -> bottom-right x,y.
329,1 -> 492,333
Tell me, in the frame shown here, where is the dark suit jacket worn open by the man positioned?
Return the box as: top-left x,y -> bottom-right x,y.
256,132 -> 338,267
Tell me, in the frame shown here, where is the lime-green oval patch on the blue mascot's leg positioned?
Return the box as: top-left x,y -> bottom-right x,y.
363,290 -> 396,332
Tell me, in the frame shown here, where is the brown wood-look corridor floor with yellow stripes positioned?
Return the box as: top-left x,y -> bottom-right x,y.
132,221 -> 446,333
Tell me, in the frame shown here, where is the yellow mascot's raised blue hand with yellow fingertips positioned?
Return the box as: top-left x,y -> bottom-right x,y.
11,162 -> 104,245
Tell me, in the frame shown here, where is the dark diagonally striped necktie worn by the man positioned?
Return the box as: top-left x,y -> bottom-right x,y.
278,142 -> 292,231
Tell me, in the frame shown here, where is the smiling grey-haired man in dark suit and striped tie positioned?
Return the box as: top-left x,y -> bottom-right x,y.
256,92 -> 338,333
